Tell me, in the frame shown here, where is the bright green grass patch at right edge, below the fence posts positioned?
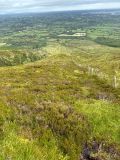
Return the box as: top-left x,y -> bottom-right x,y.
75,100 -> 120,144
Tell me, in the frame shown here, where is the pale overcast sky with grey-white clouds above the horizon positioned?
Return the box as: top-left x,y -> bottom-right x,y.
0,0 -> 120,14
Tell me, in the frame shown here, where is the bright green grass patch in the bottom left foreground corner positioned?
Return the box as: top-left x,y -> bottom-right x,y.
0,123 -> 67,160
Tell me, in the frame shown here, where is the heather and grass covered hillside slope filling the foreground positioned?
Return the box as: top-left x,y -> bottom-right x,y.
0,54 -> 120,160
